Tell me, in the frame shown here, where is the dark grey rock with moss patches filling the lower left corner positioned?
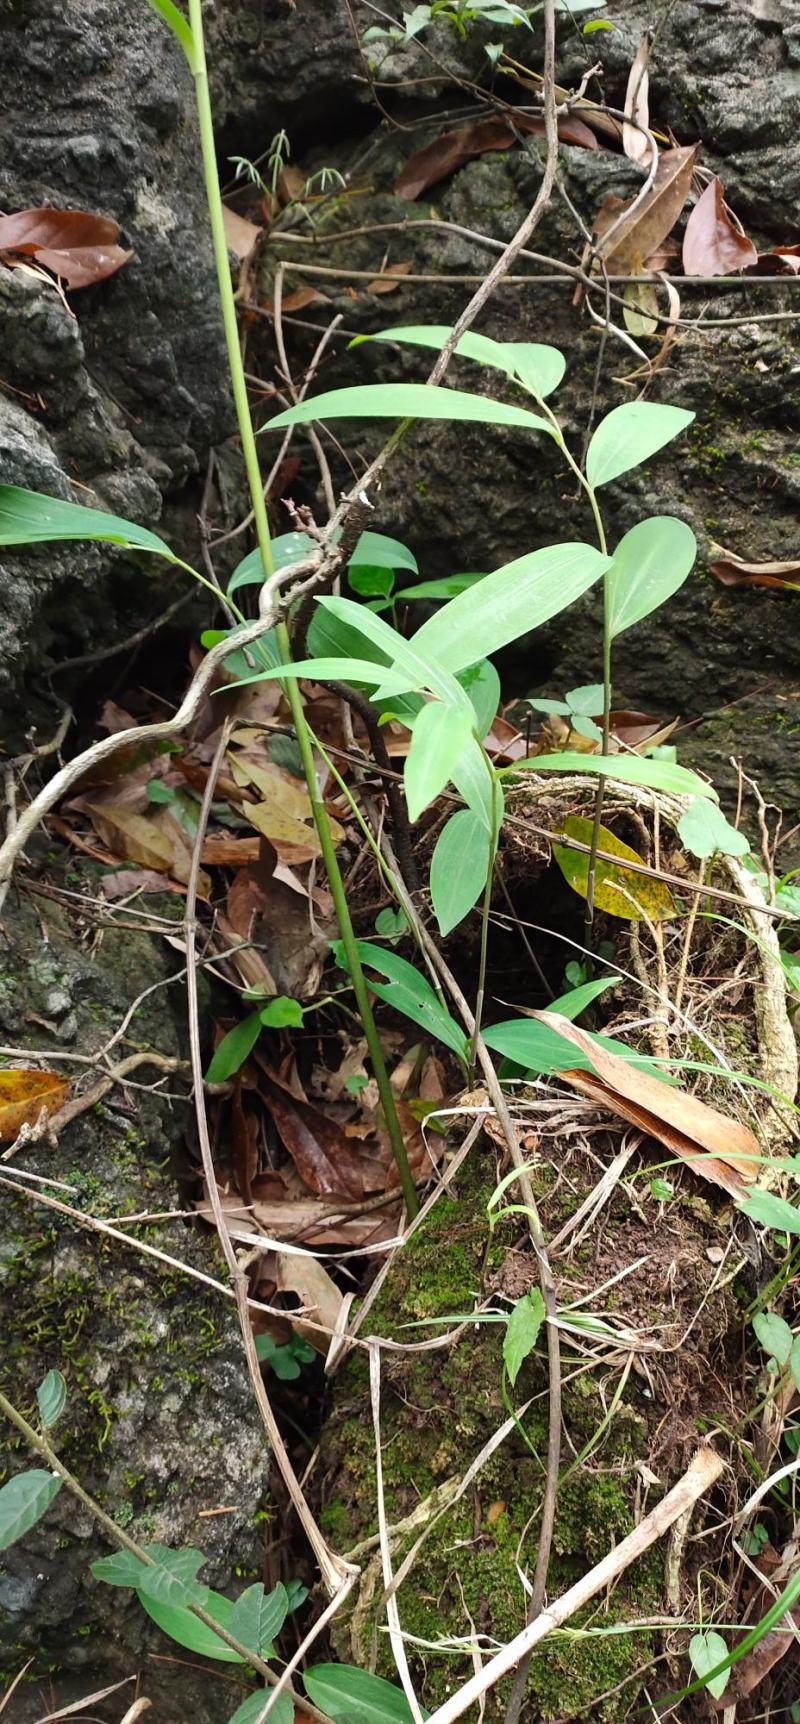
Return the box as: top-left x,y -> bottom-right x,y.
0,900 -> 269,1724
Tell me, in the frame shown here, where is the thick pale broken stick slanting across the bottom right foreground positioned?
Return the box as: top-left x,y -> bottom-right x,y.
428,1448 -> 724,1724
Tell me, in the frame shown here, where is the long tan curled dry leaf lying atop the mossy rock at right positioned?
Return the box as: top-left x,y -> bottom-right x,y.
541,1012 -> 760,1198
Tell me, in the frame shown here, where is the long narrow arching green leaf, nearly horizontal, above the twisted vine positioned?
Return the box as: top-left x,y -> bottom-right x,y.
262,383 -> 551,436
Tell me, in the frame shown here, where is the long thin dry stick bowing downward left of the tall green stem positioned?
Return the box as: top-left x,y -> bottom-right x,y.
184,721 -> 359,1598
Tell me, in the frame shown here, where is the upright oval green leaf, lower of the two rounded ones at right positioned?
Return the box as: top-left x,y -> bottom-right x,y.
605,515 -> 697,640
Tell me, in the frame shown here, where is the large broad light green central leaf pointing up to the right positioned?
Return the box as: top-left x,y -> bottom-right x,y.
412,543 -> 610,671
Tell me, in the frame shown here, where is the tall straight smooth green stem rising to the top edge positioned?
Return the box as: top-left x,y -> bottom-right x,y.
183,0 -> 419,1217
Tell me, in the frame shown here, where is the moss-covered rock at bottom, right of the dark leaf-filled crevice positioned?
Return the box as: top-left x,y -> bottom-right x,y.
319,1136 -> 736,1724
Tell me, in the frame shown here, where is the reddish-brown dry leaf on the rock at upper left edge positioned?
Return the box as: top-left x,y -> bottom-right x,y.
0,209 -> 133,288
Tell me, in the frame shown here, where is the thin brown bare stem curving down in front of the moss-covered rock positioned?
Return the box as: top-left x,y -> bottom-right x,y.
383,838 -> 560,1689
